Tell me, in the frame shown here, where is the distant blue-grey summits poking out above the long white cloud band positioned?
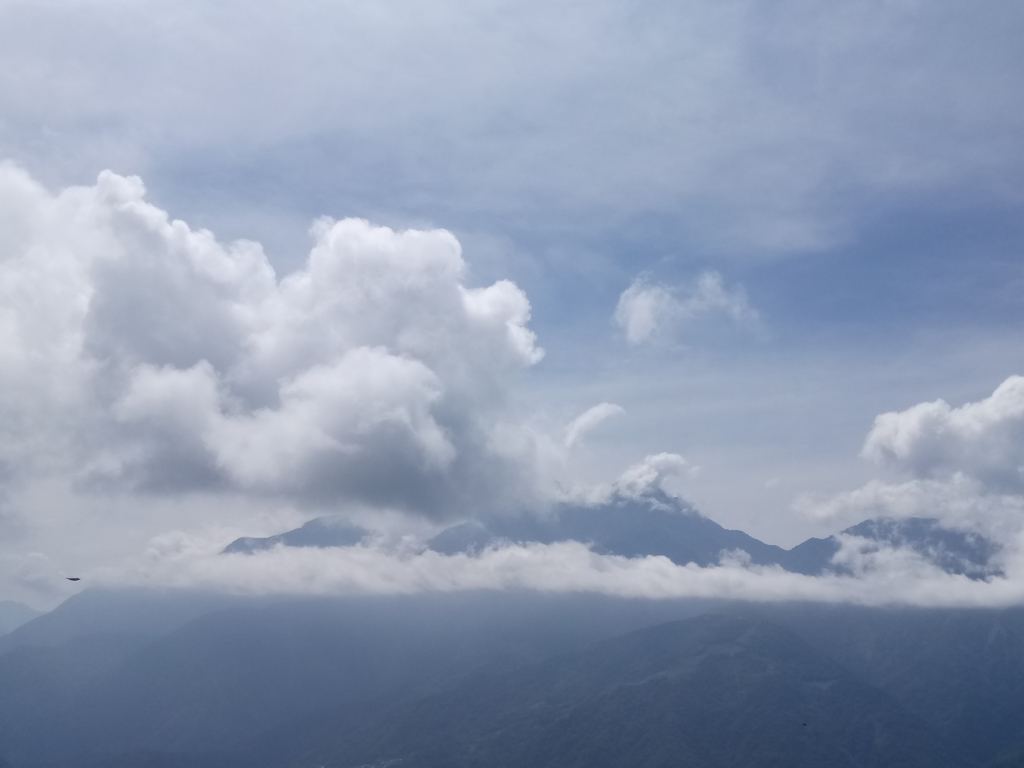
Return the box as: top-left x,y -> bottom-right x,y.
224,489 -> 999,579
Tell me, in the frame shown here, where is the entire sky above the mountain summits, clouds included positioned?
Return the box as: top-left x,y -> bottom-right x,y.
0,0 -> 1024,605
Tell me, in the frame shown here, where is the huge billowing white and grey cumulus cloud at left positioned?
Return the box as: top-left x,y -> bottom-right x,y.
0,165 -> 544,517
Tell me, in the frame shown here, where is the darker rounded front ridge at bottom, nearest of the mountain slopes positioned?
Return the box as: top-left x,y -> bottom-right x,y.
295,615 -> 961,768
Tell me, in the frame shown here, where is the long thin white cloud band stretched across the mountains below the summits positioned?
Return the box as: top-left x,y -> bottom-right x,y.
75,535 -> 1024,606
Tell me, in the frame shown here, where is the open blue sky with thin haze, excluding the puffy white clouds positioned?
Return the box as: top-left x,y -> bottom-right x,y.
0,0 -> 1024,606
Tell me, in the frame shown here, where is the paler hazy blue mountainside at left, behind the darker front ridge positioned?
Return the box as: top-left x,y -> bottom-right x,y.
0,591 -> 708,768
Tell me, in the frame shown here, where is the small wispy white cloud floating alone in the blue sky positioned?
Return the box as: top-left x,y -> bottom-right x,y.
614,271 -> 758,344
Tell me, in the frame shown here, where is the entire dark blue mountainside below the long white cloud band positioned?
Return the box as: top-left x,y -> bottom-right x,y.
6,590 -> 1024,768
